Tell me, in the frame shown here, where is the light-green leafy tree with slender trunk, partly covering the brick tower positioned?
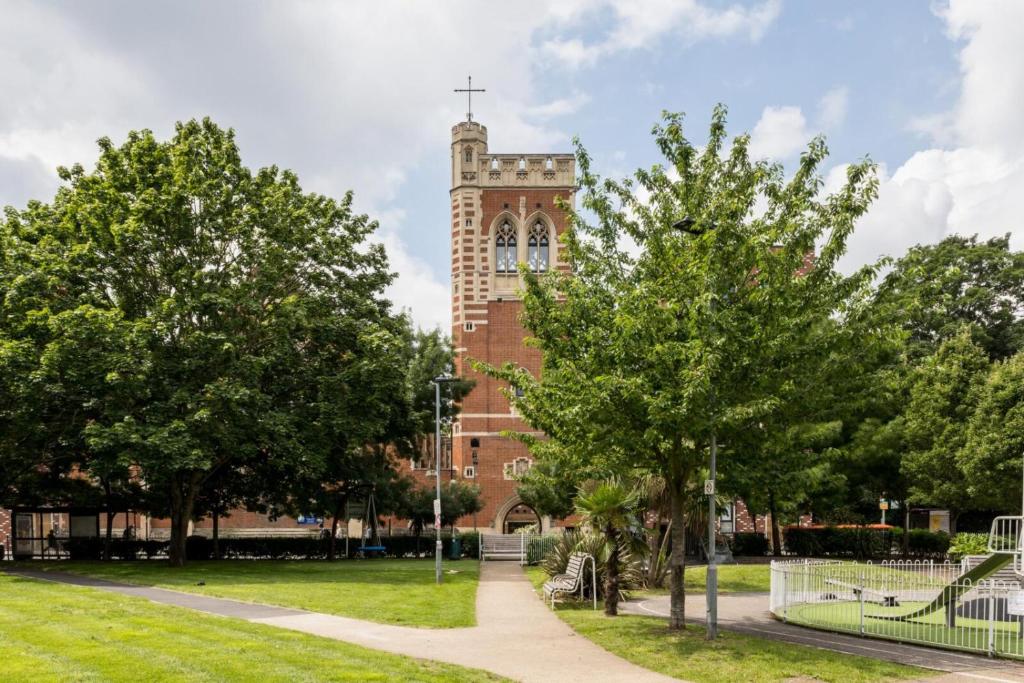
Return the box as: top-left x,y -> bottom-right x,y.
489,108 -> 877,629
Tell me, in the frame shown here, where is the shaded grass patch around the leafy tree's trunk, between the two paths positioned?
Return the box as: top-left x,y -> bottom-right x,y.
526,565 -> 935,683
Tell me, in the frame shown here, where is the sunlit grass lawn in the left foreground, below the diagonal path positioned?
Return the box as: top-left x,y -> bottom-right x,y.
0,573 -> 502,683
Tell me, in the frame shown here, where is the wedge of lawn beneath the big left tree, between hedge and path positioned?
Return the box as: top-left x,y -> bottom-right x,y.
22,559 -> 480,628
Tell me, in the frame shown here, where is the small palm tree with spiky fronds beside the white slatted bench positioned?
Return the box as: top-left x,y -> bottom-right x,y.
575,479 -> 639,616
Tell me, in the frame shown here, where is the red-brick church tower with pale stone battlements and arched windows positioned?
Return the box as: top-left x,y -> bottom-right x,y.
451,117 -> 575,533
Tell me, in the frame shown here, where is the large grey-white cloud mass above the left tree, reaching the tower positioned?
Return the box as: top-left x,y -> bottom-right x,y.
0,0 -> 589,329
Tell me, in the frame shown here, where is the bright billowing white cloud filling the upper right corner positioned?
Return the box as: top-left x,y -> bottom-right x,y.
844,0 -> 1024,268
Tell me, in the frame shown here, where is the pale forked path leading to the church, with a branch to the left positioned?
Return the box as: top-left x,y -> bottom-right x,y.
12,562 -> 676,683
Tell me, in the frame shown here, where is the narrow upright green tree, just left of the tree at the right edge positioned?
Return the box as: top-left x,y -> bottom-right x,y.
903,327 -> 989,530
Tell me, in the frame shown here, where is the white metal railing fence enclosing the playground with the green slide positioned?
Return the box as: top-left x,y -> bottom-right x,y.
770,560 -> 1024,657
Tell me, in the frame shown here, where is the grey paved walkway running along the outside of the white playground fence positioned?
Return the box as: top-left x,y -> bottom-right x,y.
622,593 -> 1024,683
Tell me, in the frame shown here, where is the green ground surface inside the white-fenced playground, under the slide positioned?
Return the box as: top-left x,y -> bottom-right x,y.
785,600 -> 1024,657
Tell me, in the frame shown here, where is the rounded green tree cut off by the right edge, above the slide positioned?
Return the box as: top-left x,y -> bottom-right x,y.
958,352 -> 1024,514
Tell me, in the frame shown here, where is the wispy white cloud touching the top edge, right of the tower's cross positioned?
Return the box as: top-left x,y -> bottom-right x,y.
542,0 -> 781,68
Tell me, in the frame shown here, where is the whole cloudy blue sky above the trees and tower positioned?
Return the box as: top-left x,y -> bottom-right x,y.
0,0 -> 1024,329
